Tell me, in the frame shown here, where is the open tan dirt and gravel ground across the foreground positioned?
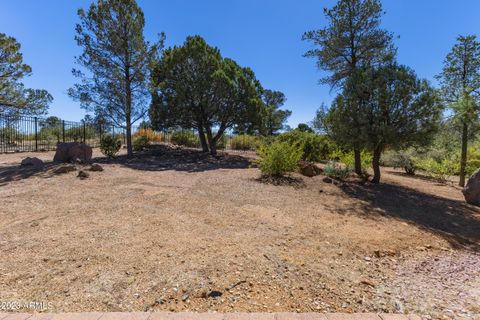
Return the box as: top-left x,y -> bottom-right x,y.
0,148 -> 480,319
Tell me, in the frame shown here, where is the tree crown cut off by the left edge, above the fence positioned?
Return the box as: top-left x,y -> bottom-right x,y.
0,33 -> 53,115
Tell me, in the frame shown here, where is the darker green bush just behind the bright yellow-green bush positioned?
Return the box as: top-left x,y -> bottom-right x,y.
278,130 -> 332,162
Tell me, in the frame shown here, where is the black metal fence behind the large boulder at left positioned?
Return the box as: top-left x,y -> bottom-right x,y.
0,114 -> 125,153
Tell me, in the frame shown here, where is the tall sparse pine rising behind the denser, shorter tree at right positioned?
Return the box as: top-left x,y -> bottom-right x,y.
303,0 -> 395,174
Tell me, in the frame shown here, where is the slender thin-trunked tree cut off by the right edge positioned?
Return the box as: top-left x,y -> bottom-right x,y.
438,36 -> 480,187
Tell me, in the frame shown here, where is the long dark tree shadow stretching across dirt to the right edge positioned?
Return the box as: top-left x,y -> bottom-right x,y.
331,183 -> 480,252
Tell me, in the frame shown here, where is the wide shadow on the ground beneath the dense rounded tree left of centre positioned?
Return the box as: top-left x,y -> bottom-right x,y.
94,146 -> 252,172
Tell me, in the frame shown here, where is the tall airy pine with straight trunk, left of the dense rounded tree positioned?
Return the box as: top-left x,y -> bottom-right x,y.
69,0 -> 164,156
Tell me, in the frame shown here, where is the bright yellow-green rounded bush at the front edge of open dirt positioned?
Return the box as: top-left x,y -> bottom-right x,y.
257,141 -> 302,177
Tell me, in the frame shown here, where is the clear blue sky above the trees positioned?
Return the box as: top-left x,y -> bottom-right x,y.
0,0 -> 480,126
